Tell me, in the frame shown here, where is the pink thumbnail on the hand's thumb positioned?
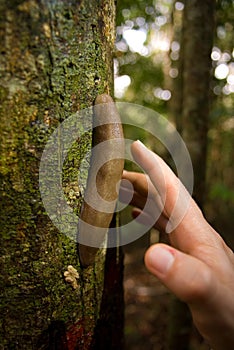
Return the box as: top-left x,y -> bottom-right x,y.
147,245 -> 175,274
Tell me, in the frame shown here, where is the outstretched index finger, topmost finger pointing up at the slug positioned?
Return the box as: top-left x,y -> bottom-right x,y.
132,141 -> 218,252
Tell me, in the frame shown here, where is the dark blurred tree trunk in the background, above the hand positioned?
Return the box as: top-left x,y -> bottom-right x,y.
182,0 -> 215,207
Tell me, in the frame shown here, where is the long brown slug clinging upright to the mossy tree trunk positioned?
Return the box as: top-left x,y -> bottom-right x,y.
78,94 -> 125,267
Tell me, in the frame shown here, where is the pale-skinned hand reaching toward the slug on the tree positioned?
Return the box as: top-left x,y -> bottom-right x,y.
120,141 -> 234,350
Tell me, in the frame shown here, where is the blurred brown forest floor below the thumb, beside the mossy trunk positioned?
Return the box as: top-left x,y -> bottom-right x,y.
124,232 -> 210,350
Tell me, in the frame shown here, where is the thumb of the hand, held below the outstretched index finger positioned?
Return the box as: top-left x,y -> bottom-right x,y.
145,243 -> 214,303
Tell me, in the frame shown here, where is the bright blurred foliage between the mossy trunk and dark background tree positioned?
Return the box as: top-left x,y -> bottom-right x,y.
116,0 -> 172,113
